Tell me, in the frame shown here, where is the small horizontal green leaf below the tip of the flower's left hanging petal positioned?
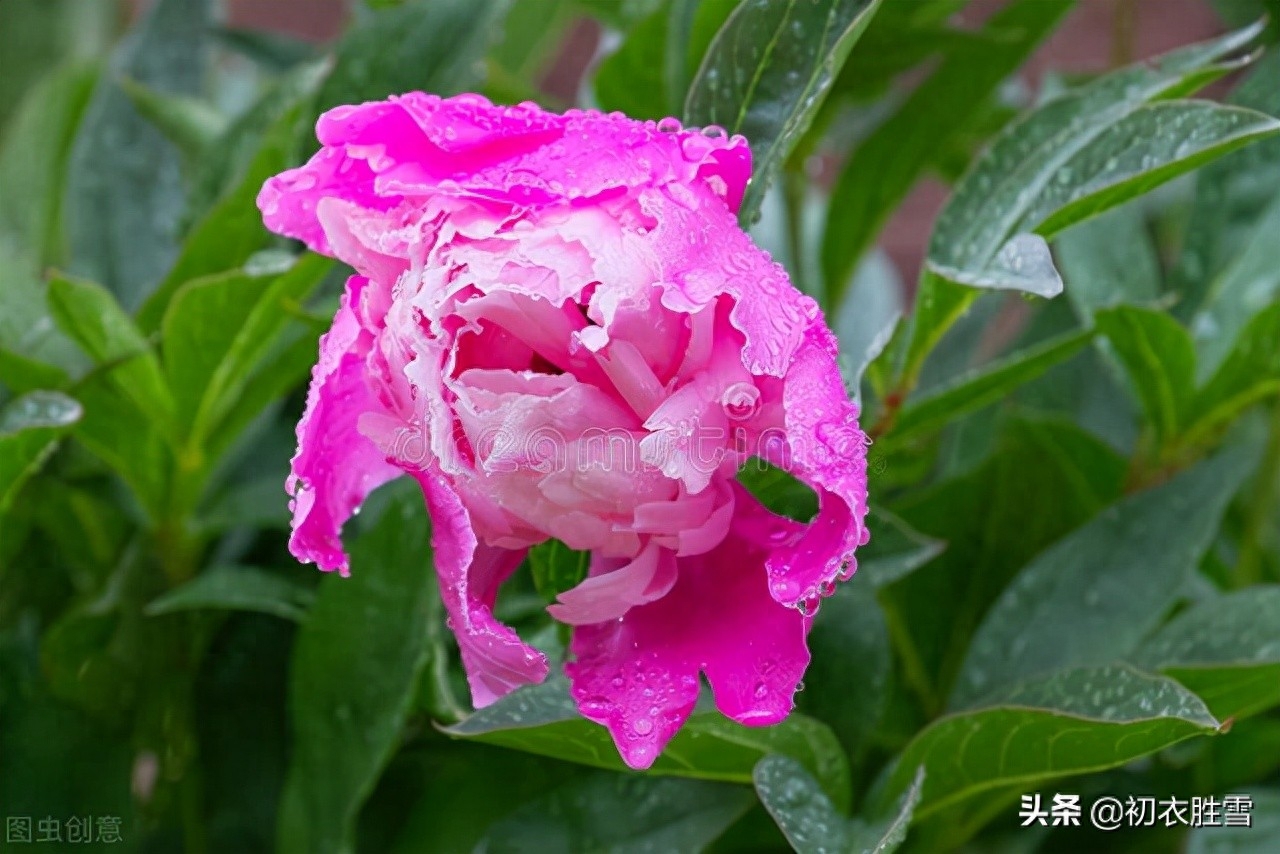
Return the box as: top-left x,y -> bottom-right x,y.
145,566 -> 315,622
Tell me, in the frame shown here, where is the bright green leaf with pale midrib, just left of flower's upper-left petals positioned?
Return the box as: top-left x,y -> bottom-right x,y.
163,254 -> 333,447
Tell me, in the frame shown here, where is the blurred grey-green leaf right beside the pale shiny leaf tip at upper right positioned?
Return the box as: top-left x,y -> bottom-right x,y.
1053,204 -> 1161,324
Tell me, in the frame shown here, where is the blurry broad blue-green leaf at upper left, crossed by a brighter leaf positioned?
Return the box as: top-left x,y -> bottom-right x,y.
64,0 -> 211,310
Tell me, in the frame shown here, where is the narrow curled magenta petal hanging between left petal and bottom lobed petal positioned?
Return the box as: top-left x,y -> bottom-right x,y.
411,471 -> 547,708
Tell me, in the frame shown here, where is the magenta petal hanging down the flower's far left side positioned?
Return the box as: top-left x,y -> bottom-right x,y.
285,277 -> 401,575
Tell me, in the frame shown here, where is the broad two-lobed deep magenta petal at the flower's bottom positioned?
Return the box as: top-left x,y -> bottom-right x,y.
566,487 -> 810,768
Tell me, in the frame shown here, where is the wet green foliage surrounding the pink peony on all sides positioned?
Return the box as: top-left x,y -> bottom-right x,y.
0,0 -> 1280,854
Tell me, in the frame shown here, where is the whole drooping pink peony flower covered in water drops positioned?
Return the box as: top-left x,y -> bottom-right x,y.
259,93 -> 867,768
